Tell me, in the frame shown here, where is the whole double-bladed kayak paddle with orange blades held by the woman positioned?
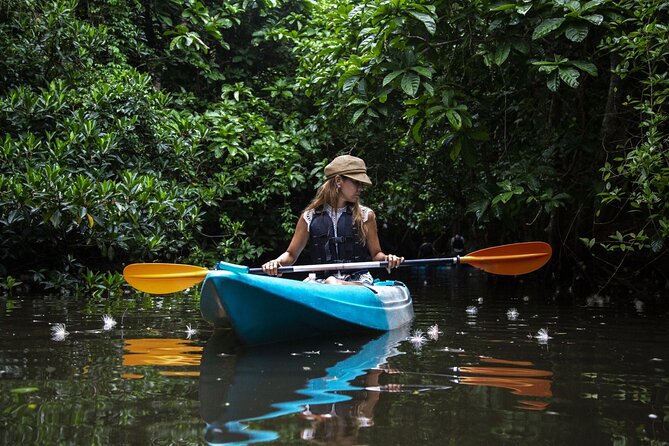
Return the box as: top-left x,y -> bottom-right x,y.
123,242 -> 553,294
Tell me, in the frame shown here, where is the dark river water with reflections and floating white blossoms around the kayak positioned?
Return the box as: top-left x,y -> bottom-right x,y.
0,267 -> 669,445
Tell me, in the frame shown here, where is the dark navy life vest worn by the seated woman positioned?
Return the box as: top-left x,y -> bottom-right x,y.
309,207 -> 372,263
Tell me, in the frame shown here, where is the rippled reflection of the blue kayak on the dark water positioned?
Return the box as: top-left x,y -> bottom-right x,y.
200,325 -> 409,444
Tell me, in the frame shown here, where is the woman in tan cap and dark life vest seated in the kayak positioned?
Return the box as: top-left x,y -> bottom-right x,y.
262,155 -> 404,285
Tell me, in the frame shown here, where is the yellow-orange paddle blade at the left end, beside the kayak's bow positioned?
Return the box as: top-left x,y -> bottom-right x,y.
123,263 -> 209,294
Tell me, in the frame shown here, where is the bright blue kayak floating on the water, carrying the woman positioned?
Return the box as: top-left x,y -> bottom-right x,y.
200,270 -> 413,345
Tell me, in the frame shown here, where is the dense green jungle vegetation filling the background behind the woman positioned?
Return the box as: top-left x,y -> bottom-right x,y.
0,0 -> 669,300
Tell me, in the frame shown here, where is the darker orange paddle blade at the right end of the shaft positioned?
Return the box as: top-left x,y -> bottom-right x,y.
460,242 -> 553,276
